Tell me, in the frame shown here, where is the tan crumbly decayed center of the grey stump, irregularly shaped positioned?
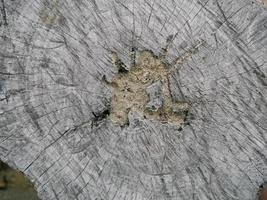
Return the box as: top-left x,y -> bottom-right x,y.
110,51 -> 189,125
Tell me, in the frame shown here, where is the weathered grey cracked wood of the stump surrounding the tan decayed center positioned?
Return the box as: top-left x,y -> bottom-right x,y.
0,0 -> 267,200
